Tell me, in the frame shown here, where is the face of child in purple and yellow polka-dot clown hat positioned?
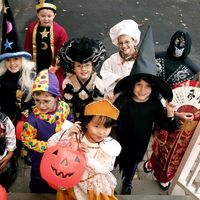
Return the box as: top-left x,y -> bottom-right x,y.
33,92 -> 57,114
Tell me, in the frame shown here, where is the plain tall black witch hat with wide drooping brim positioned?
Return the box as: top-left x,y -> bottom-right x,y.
114,26 -> 173,101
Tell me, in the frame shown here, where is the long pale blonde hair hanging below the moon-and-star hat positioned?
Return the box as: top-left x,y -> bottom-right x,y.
0,57 -> 36,102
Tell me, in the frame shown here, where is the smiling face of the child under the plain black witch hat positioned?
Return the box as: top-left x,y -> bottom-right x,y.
133,80 -> 152,102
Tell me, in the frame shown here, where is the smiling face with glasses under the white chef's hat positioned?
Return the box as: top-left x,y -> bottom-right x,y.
118,35 -> 136,57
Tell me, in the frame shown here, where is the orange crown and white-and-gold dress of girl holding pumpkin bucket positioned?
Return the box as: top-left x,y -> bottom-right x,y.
48,99 -> 121,200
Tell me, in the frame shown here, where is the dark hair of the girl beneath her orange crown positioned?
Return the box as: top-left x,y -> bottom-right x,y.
80,115 -> 116,138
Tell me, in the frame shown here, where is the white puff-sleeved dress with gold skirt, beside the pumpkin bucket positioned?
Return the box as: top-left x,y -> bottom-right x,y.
58,137 -> 121,200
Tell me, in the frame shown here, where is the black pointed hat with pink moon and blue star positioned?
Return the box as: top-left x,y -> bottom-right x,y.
0,0 -> 32,61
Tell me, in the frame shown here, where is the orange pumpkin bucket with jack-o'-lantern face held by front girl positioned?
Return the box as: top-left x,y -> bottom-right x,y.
40,145 -> 86,189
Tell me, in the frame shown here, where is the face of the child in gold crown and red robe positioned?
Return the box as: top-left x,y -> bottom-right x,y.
37,9 -> 56,27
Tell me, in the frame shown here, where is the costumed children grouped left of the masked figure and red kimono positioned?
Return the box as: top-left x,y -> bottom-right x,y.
0,0 -> 198,200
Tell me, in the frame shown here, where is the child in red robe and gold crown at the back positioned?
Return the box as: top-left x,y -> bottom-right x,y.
24,0 -> 68,72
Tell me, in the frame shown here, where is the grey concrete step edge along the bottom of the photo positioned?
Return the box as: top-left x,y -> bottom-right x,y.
8,193 -> 193,200
